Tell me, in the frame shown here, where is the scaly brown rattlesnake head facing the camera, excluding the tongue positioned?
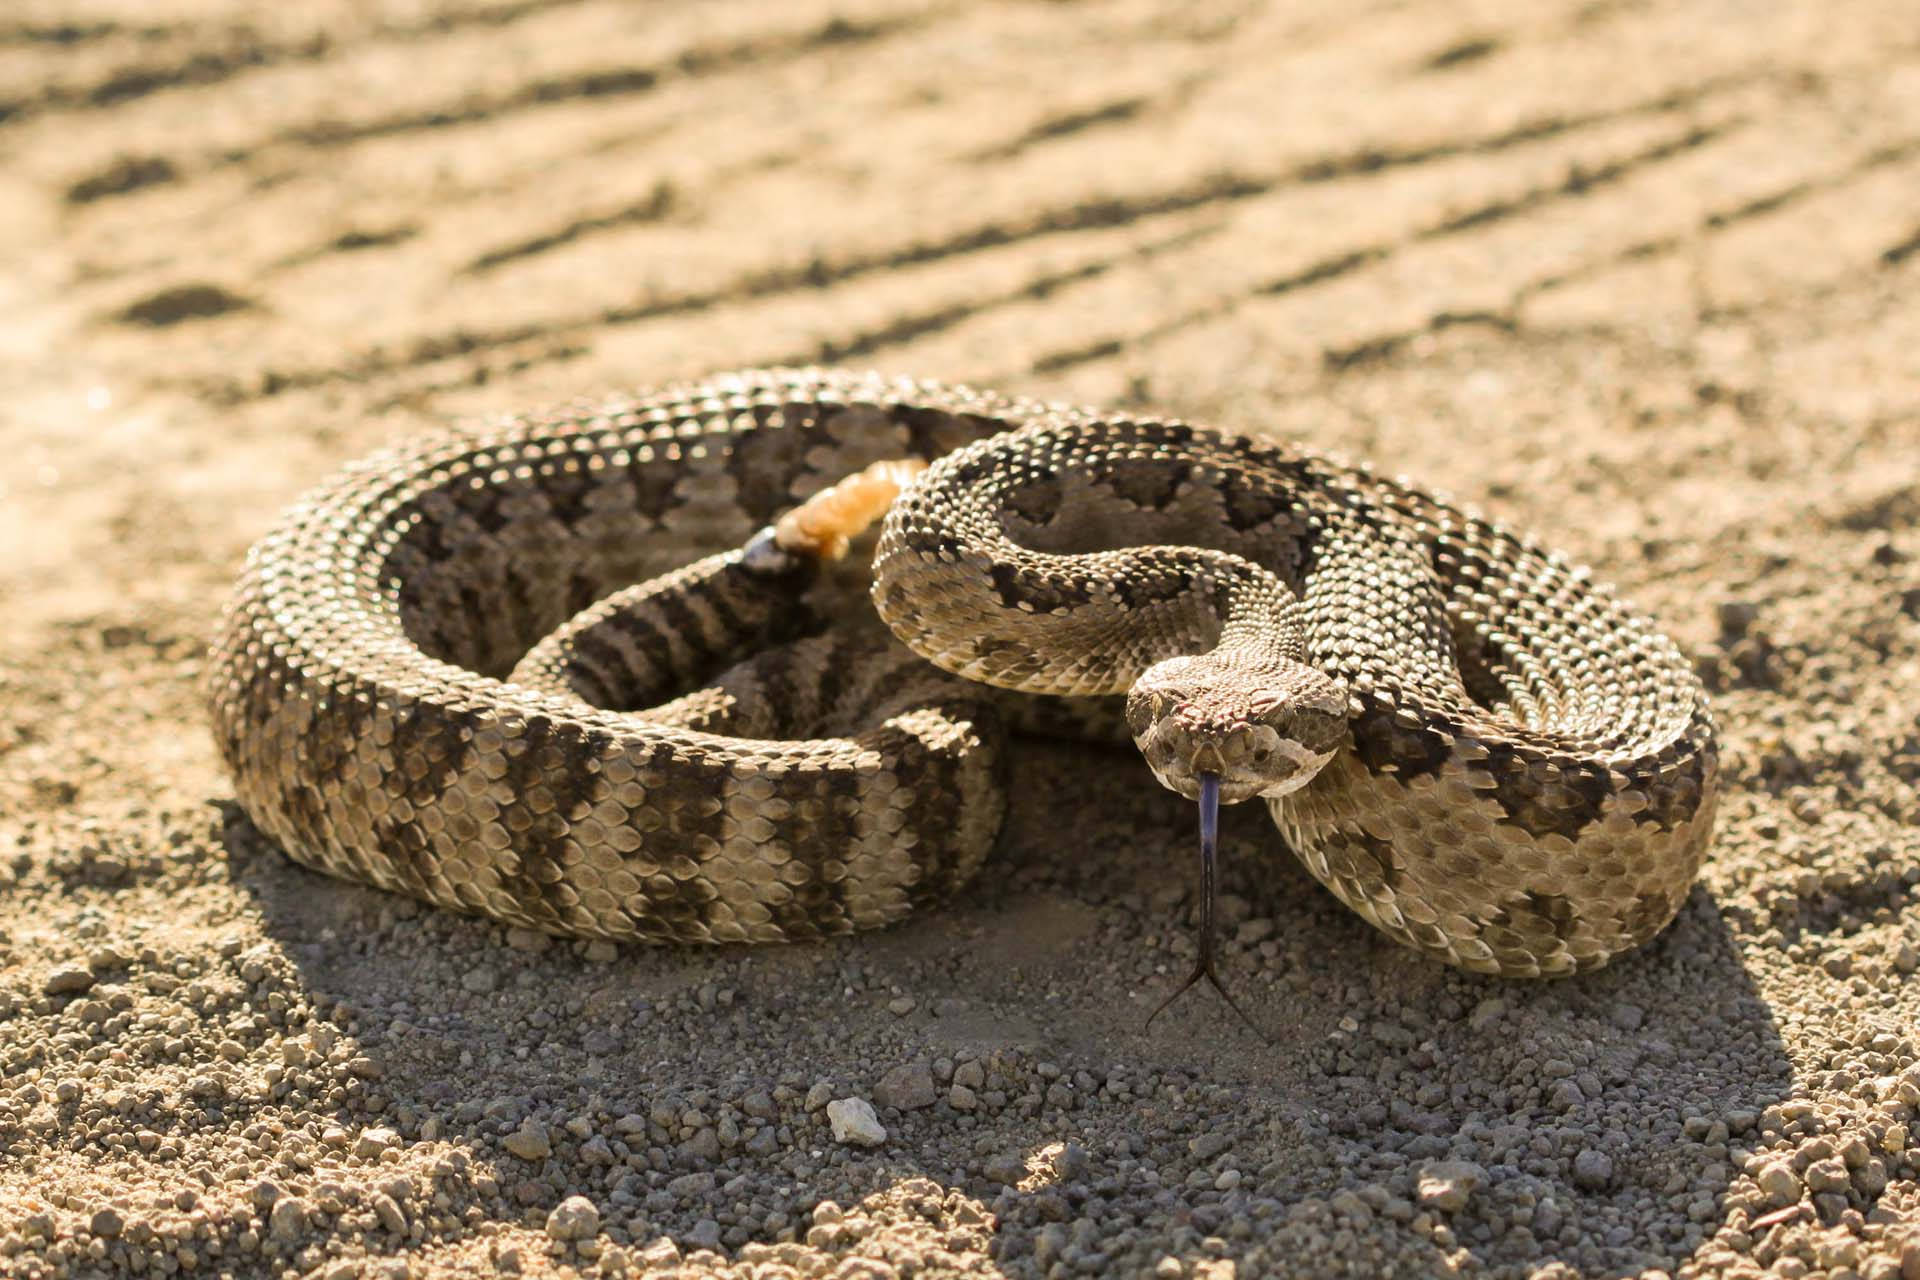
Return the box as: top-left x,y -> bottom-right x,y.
1127,651 -> 1346,804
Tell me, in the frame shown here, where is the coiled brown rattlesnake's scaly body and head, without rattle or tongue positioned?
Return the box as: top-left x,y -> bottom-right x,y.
211,370 -> 1716,975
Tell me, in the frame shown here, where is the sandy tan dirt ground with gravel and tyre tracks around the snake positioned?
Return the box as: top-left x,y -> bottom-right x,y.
0,0 -> 1920,1280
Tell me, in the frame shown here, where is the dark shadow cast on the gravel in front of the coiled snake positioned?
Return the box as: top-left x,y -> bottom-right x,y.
225,745 -> 1793,1276
